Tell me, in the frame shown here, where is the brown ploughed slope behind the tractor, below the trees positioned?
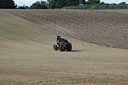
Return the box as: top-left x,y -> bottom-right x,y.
3,10 -> 128,49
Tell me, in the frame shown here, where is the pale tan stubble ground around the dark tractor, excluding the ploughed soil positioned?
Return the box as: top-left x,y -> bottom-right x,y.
0,11 -> 128,85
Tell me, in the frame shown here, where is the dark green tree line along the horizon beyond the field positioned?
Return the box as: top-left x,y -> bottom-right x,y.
0,0 -> 128,9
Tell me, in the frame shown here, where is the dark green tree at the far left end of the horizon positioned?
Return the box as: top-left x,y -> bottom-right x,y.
0,0 -> 17,9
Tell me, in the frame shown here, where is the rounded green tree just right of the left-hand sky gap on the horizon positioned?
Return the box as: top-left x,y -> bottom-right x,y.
30,1 -> 48,9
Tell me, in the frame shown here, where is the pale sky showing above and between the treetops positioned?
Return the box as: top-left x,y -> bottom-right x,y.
14,0 -> 128,6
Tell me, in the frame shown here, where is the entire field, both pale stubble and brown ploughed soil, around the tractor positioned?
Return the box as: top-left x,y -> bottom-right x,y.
0,10 -> 128,85
